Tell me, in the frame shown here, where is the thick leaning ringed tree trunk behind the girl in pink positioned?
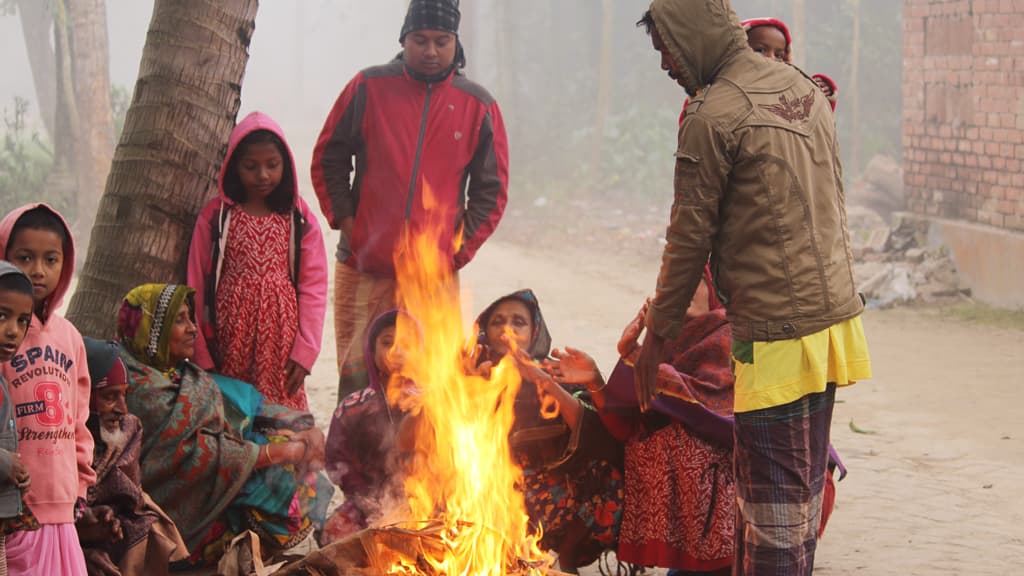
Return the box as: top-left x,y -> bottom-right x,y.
68,0 -> 258,337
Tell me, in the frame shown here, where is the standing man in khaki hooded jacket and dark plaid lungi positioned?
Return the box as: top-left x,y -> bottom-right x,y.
636,0 -> 870,576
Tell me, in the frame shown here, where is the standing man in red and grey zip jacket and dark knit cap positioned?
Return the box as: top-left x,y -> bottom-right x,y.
312,0 -> 508,402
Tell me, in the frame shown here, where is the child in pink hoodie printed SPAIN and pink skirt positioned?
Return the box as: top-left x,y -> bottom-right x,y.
0,204 -> 96,576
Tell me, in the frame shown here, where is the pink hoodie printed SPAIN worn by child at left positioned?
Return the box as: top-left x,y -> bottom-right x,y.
0,204 -> 96,524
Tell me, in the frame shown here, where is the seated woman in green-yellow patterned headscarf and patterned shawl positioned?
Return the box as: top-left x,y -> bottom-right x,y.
118,284 -> 333,565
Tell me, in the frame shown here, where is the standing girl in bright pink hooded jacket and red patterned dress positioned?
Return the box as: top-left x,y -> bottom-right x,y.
188,112 -> 327,410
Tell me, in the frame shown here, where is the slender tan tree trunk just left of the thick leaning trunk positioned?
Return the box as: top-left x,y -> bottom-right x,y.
63,0 -> 114,240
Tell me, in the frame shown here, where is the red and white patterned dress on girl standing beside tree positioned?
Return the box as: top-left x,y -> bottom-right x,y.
216,209 -> 299,410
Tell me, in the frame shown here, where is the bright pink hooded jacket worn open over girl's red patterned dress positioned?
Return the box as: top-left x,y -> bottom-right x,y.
188,112 -> 327,371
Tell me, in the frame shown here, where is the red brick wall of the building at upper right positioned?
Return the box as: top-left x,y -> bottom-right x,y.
903,0 -> 1024,232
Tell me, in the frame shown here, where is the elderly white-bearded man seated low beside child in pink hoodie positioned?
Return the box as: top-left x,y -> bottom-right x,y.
77,338 -> 187,576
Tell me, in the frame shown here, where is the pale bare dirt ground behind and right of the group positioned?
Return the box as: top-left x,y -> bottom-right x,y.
307,230 -> 1024,575
